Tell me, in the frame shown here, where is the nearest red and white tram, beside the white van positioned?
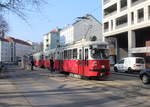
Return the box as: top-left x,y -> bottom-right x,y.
33,41 -> 110,78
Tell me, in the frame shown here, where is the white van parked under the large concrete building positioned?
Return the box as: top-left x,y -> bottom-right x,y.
114,57 -> 145,72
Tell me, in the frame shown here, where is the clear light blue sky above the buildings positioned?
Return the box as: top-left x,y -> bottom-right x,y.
4,0 -> 102,42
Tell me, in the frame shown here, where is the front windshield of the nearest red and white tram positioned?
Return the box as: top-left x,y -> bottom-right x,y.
91,49 -> 108,59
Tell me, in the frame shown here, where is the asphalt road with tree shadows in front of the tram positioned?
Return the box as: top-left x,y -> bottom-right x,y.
0,67 -> 150,107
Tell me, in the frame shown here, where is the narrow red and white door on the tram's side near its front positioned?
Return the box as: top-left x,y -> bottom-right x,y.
78,48 -> 84,75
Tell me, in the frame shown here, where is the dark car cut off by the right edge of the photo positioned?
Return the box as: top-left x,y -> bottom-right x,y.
140,69 -> 150,84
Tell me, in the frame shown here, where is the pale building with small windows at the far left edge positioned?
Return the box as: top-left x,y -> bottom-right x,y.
0,38 -> 11,62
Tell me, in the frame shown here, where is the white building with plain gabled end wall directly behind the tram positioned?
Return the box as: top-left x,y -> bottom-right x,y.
60,14 -> 103,45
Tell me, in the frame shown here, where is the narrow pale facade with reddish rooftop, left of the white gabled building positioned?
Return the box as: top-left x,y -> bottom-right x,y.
43,29 -> 60,51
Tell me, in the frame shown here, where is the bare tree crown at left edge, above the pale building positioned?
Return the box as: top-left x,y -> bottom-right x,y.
0,15 -> 9,37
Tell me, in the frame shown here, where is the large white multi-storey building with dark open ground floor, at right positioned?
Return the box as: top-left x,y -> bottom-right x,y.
103,0 -> 150,66
